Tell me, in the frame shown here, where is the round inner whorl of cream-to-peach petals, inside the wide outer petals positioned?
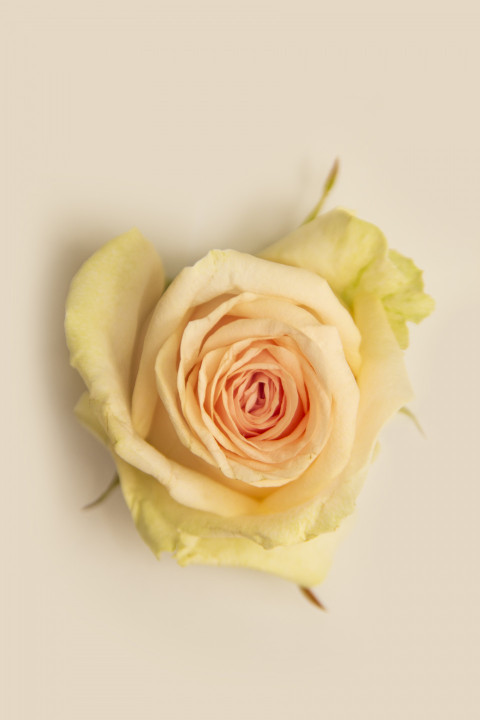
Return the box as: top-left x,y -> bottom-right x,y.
152,293 -> 355,488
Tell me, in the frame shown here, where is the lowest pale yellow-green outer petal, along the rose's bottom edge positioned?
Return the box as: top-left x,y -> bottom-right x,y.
117,460 -> 348,586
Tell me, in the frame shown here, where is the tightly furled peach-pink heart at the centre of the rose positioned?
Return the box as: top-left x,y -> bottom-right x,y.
180,337 -> 331,484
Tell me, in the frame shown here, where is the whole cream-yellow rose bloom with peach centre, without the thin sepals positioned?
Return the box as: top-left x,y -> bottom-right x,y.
66,210 -> 432,586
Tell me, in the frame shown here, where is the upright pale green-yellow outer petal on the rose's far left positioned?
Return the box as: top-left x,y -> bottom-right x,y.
65,230 -> 164,442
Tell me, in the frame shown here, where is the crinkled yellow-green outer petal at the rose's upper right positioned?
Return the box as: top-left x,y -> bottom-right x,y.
260,209 -> 434,348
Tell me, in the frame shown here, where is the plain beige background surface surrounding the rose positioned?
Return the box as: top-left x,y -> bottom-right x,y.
0,0 -> 480,720
